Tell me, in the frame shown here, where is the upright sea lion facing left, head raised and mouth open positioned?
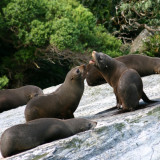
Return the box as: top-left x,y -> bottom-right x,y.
90,51 -> 150,111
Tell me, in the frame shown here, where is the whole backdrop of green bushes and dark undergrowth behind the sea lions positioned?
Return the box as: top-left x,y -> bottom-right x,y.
0,0 -> 160,88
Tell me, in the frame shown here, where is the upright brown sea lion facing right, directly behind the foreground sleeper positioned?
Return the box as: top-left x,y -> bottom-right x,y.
25,65 -> 86,121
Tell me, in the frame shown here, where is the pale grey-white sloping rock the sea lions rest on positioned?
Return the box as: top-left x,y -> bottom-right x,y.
0,75 -> 160,160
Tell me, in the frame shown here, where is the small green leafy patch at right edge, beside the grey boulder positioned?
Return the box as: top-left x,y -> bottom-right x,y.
144,34 -> 160,57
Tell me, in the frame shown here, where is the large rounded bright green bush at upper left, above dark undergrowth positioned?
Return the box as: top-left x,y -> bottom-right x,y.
3,0 -> 121,52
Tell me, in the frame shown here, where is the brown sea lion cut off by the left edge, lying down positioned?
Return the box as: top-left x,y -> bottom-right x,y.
0,85 -> 43,113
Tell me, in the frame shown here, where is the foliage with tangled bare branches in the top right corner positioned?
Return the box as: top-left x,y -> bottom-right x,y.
119,0 -> 160,26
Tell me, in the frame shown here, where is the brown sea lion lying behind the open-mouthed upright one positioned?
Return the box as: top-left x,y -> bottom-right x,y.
86,54 -> 160,86
